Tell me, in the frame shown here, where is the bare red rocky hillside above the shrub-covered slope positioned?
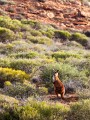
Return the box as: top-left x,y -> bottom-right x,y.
0,0 -> 90,31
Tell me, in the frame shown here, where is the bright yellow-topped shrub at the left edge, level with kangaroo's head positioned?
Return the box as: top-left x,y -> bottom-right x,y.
0,67 -> 29,87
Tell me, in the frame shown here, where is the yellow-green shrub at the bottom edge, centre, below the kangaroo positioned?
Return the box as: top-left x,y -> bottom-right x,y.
28,100 -> 69,120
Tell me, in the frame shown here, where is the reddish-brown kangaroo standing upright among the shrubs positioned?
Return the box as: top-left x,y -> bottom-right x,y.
53,71 -> 65,99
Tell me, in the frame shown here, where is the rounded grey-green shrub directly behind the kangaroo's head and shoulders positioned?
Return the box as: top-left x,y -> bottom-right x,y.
41,63 -> 78,83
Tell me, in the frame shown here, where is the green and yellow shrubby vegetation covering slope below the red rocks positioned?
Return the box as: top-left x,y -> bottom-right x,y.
0,16 -> 90,120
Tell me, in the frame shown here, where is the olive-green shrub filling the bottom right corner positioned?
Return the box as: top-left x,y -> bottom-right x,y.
67,100 -> 90,120
